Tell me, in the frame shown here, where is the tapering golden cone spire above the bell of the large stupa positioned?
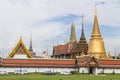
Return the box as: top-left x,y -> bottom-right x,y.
91,5 -> 101,37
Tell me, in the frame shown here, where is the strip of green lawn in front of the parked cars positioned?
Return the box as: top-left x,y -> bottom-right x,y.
0,74 -> 120,80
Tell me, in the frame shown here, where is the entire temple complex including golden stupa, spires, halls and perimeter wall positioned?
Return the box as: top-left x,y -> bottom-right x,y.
0,8 -> 120,75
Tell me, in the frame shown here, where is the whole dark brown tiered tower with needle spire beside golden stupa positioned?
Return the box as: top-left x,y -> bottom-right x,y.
79,15 -> 88,55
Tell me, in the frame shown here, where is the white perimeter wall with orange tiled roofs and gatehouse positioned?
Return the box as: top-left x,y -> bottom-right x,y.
0,55 -> 120,75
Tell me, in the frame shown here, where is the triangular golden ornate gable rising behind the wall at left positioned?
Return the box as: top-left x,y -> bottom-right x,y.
8,38 -> 33,58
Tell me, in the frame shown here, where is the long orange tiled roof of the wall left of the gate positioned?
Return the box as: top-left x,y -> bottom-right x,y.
2,59 -> 75,67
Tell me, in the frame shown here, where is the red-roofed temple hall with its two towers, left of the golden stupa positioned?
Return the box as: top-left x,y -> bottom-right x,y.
52,17 -> 88,59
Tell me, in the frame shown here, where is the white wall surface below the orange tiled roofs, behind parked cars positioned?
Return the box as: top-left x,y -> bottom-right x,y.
0,67 -> 120,73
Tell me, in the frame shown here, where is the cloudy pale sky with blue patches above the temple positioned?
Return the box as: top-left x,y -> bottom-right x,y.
0,0 -> 120,57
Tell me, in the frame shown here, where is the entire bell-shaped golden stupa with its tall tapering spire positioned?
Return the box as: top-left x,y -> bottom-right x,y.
88,6 -> 106,58
